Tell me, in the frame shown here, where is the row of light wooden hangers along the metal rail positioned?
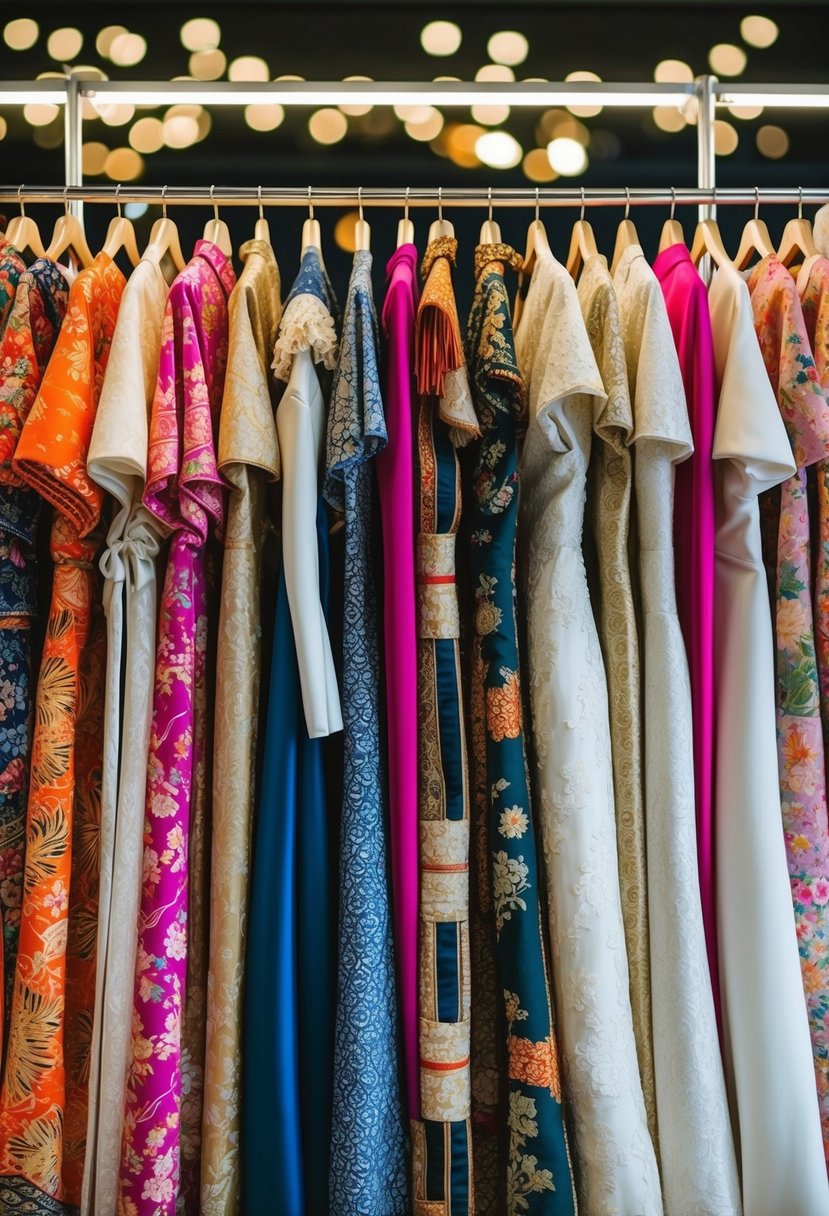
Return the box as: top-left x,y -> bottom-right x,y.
6,186 -> 818,286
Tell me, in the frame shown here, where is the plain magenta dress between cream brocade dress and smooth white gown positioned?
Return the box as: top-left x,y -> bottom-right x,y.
654,244 -> 720,1021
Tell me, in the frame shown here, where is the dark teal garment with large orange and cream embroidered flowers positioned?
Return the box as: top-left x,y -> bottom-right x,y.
468,244 -> 576,1216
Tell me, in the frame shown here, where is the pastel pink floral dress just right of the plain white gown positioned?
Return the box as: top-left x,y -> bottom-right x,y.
749,255 -> 829,1167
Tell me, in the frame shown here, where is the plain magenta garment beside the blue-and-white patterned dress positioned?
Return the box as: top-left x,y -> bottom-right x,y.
376,244 -> 421,1121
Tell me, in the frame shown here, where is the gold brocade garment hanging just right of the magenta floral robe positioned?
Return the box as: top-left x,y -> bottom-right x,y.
201,241 -> 282,1216
